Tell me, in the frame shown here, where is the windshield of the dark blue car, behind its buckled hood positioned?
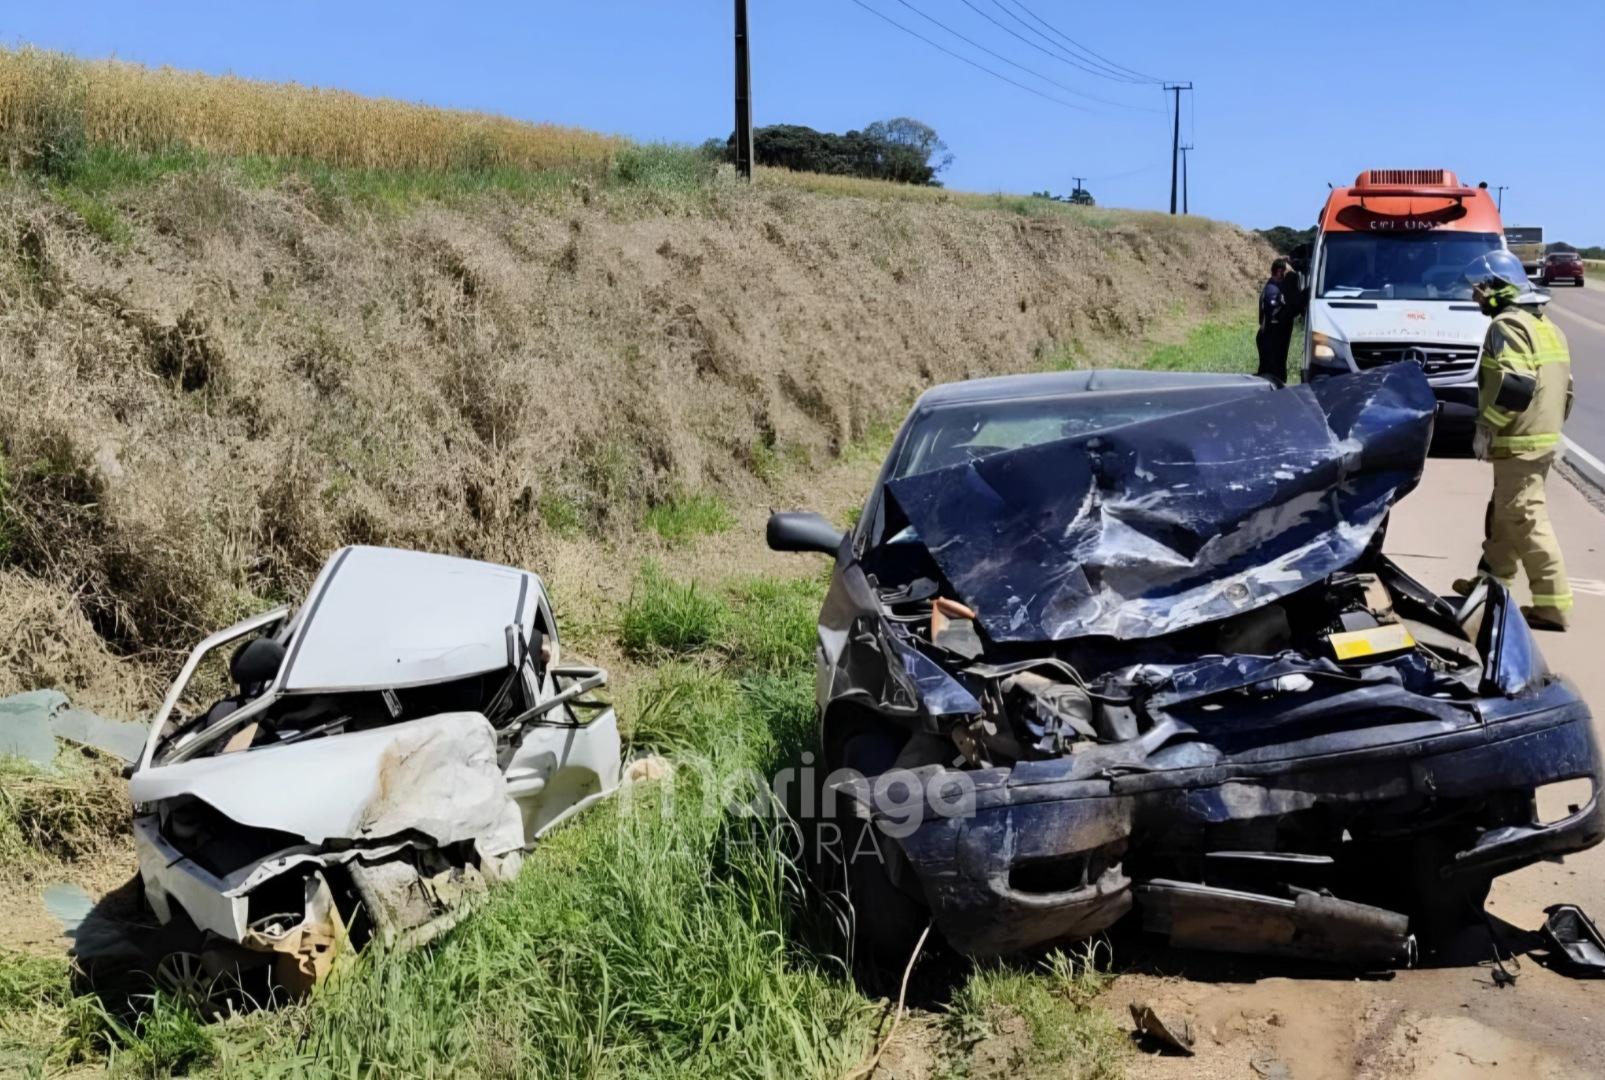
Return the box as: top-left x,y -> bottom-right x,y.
891,382 -> 1268,480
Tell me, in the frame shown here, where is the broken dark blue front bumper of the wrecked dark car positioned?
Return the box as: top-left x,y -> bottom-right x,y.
841,680 -> 1605,960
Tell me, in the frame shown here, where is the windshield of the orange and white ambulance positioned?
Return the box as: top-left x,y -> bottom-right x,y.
1316,233 -> 1501,300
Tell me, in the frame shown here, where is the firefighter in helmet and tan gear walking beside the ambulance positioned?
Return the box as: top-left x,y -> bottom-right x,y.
1454,250 -> 1573,631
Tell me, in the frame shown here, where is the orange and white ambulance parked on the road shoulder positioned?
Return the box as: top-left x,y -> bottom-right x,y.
1303,168 -> 1505,435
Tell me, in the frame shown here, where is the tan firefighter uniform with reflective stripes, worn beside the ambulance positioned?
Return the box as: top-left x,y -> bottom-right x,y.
1477,307 -> 1571,618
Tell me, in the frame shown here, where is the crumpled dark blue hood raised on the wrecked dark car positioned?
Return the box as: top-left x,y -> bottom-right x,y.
888,364 -> 1435,642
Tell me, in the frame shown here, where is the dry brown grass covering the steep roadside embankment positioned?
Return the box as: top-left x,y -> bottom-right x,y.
0,151 -> 1263,699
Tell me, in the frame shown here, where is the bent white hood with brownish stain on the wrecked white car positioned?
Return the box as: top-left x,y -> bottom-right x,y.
128,713 -> 523,855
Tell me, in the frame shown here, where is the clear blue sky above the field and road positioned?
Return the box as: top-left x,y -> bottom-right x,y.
12,0 -> 1605,244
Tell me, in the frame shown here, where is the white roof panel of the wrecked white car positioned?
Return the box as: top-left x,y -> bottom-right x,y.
281,547 -> 541,693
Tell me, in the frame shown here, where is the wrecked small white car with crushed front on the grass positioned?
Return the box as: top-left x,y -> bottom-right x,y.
130,547 -> 620,990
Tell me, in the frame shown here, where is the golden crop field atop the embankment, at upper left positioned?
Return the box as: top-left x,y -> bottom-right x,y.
0,48 -> 623,172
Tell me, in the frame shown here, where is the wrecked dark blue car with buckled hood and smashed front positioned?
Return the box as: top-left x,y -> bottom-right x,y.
769,364 -> 1605,966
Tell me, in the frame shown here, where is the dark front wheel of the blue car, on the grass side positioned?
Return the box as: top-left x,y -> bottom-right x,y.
836,735 -> 931,974
